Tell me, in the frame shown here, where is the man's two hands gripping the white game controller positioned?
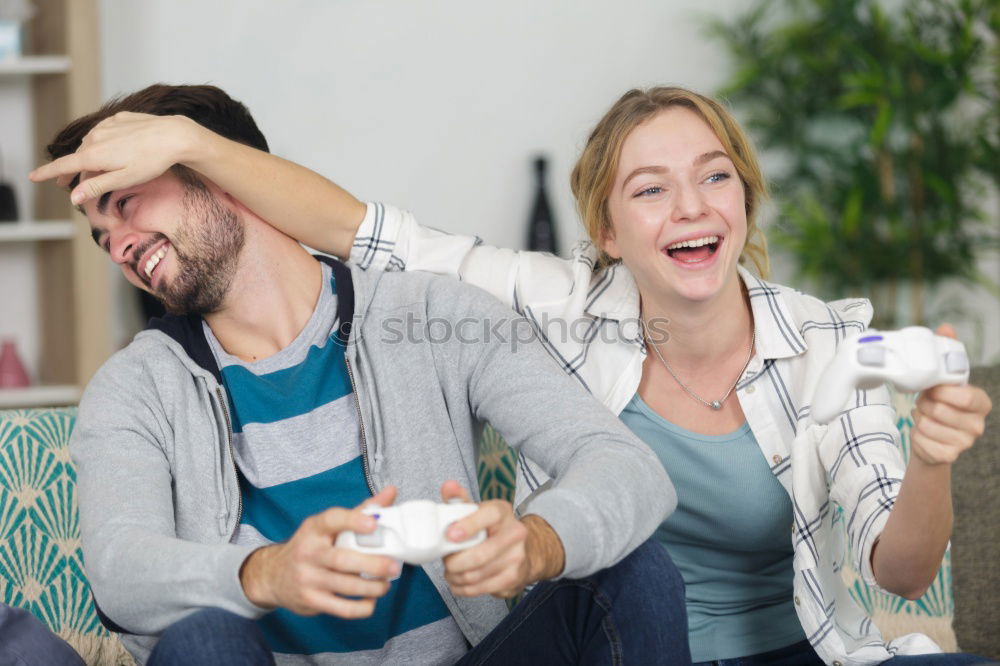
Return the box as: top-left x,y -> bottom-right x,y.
240,481 -> 563,618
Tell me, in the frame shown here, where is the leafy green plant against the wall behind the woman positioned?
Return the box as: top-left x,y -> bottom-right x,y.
709,0 -> 1000,328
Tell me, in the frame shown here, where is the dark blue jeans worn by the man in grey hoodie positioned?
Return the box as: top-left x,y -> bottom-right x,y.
148,540 -> 691,666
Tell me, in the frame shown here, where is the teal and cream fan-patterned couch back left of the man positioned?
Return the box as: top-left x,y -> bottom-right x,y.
0,408 -> 133,666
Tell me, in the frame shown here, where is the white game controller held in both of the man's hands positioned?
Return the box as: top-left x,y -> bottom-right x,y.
336,500 -> 486,564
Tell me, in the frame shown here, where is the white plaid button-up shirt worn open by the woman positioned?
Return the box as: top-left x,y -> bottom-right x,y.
351,204 -> 940,665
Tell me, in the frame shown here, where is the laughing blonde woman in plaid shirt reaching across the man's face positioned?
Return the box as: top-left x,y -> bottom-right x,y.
33,88 -> 990,664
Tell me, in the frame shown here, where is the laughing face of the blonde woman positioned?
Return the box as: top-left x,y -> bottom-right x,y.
603,106 -> 747,301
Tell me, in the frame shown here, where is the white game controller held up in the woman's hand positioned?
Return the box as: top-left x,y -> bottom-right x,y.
812,326 -> 969,423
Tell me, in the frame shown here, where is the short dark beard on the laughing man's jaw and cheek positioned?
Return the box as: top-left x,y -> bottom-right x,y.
153,181 -> 245,315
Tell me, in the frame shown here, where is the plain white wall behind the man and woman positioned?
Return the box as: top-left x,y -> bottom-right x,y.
101,0 -> 1000,358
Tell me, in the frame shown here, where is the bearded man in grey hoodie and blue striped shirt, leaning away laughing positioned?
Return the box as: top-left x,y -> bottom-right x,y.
32,85 -> 688,664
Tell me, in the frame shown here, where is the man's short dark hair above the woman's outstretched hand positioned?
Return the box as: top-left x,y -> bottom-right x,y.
47,83 -> 270,167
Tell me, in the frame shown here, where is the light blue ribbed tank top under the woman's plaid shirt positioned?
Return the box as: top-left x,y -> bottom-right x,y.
621,394 -> 805,662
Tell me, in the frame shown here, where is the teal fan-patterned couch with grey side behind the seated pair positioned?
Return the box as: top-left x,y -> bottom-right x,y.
0,366 -> 1000,665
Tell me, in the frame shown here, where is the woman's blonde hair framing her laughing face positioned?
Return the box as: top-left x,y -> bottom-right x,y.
570,87 -> 770,278
